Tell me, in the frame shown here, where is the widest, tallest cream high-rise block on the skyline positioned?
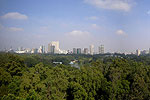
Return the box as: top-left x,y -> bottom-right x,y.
48,41 -> 60,53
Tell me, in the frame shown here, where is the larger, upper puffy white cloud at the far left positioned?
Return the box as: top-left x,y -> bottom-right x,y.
1,12 -> 28,20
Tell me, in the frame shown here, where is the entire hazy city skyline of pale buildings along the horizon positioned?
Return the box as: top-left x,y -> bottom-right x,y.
0,41 -> 150,56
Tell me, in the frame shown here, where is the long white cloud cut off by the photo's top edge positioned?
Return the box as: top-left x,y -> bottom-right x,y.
84,0 -> 131,11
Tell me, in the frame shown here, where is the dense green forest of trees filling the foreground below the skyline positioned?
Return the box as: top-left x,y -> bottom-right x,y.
0,53 -> 150,100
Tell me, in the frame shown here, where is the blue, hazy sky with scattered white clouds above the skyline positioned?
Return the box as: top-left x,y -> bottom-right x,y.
0,0 -> 150,52
